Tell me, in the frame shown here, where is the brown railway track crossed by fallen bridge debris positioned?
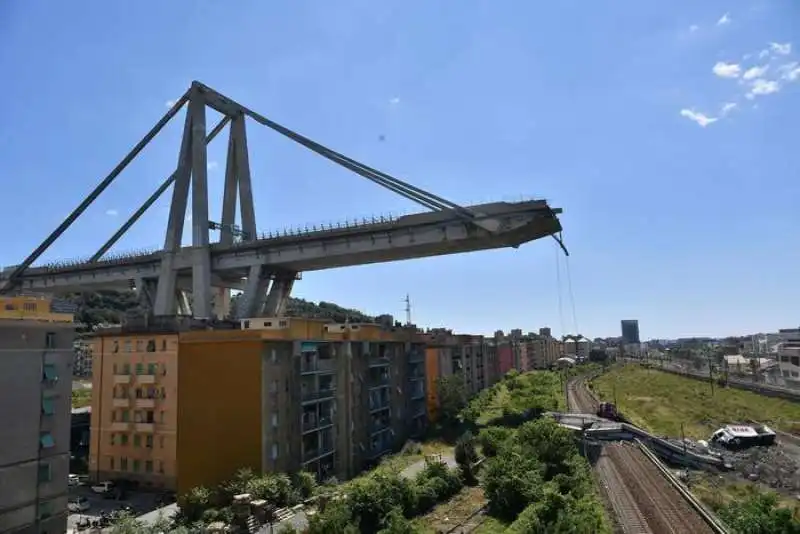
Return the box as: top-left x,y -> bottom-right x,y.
567,379 -> 726,534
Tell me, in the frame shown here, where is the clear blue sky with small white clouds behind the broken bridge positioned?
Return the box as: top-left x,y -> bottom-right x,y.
0,0 -> 800,337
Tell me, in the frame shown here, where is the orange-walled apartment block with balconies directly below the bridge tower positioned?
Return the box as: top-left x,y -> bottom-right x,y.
90,317 -> 427,493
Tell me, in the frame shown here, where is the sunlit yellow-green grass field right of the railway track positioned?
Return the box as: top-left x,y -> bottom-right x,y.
592,365 -> 800,439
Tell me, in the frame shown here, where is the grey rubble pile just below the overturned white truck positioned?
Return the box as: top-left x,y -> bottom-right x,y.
726,447 -> 800,492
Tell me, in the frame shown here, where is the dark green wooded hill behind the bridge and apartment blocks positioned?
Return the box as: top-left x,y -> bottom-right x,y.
63,291 -> 376,330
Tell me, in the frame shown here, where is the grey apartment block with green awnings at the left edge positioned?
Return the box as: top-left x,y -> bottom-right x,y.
0,297 -> 75,534
